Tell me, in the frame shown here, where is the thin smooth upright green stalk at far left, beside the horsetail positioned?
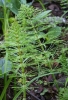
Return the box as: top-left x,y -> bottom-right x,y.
3,0 -> 8,100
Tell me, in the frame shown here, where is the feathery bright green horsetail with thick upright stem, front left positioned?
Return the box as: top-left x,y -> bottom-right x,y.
5,5 -> 50,100
